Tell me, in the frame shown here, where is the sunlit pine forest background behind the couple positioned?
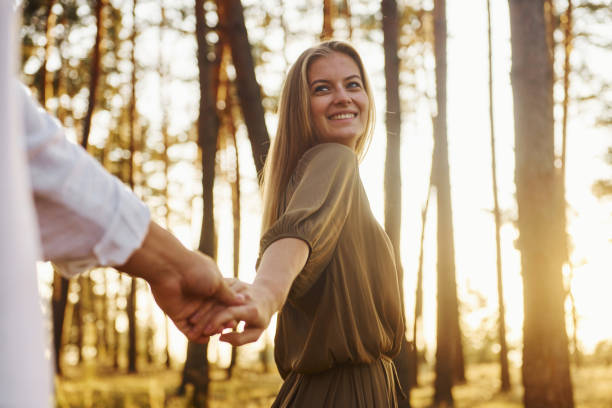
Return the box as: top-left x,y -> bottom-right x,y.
19,0 -> 612,408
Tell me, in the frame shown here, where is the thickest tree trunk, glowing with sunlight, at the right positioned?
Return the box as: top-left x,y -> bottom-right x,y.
509,0 -> 574,408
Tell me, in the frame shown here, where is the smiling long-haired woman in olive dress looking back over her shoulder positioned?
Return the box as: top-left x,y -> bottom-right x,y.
194,41 -> 404,408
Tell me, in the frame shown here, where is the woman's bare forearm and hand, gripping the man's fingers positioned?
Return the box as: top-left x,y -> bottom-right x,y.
191,238 -> 309,346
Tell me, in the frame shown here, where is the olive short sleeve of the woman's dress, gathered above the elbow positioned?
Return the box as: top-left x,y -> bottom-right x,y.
260,143 -> 359,296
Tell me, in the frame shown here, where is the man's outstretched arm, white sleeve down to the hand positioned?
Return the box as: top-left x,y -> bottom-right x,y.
16,83 -> 240,341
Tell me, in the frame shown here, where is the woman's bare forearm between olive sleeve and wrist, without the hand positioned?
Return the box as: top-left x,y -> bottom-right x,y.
253,238 -> 310,312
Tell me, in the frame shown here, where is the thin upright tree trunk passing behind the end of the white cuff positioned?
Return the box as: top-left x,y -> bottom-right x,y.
128,0 -> 138,373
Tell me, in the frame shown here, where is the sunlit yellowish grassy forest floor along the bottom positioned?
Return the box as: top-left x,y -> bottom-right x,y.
56,364 -> 612,408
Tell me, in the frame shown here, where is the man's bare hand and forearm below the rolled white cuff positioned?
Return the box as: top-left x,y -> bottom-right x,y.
119,222 -> 244,343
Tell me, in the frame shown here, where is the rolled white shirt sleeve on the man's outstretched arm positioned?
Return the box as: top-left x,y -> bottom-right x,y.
17,84 -> 150,276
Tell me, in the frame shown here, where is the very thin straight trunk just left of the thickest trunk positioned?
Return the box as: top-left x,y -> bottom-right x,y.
487,0 -> 510,392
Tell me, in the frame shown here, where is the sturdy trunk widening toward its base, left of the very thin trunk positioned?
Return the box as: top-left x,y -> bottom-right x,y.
434,0 -> 465,406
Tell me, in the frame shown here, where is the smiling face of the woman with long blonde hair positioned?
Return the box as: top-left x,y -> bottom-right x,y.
308,52 -> 369,149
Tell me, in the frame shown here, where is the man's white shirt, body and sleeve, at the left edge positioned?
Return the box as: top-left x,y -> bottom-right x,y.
0,0 -> 150,408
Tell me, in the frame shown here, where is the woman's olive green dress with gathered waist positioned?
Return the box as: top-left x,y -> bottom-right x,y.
260,143 -> 404,408
